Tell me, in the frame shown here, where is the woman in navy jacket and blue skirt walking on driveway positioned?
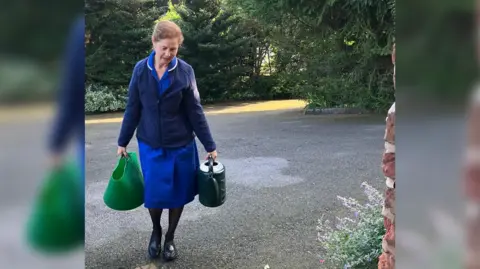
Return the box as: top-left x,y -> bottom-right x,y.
117,21 -> 217,261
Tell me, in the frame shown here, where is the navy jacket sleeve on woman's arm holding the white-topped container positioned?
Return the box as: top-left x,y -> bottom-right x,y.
184,68 -> 217,152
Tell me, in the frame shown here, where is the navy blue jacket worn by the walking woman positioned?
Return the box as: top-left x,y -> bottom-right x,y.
118,57 -> 216,152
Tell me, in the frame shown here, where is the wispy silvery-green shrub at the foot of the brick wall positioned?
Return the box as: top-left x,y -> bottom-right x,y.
318,182 -> 385,269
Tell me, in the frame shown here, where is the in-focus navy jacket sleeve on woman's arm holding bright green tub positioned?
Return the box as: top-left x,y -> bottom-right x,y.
118,63 -> 142,147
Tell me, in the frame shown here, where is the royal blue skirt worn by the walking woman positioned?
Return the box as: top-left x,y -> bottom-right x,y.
138,139 -> 200,209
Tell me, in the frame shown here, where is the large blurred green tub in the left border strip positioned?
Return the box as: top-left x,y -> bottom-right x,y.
26,159 -> 85,252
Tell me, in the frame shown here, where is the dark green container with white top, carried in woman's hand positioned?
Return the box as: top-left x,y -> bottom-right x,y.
198,156 -> 226,207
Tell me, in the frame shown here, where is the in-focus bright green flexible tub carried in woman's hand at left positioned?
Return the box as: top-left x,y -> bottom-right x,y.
103,152 -> 145,211
